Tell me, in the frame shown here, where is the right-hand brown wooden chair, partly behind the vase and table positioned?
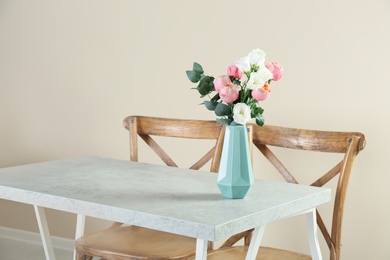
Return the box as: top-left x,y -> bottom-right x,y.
207,125 -> 365,260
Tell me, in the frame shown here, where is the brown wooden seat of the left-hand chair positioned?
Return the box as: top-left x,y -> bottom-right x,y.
75,226 -> 196,260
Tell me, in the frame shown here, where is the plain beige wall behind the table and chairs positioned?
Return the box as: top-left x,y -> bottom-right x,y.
0,0 -> 390,260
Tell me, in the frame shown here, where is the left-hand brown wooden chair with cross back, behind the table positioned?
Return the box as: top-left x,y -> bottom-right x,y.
75,116 -> 223,260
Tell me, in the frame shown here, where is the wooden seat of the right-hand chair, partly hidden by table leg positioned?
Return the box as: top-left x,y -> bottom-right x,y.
207,246 -> 311,260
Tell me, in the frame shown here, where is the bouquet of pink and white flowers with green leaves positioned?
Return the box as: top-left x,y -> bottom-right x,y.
186,49 -> 283,126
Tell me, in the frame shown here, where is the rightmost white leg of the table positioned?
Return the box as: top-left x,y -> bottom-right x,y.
306,208 -> 322,260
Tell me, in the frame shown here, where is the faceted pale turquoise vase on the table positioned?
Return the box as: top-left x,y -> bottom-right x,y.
217,125 -> 253,199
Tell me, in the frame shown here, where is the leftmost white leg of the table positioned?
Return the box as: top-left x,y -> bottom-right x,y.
34,205 -> 56,260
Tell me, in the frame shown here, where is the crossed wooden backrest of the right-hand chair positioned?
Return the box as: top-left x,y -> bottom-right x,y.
252,125 -> 365,260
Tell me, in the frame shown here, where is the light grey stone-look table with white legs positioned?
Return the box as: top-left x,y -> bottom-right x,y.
0,156 -> 331,260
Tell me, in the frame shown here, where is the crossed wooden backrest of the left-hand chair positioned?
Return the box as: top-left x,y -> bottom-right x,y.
123,116 -> 223,172
